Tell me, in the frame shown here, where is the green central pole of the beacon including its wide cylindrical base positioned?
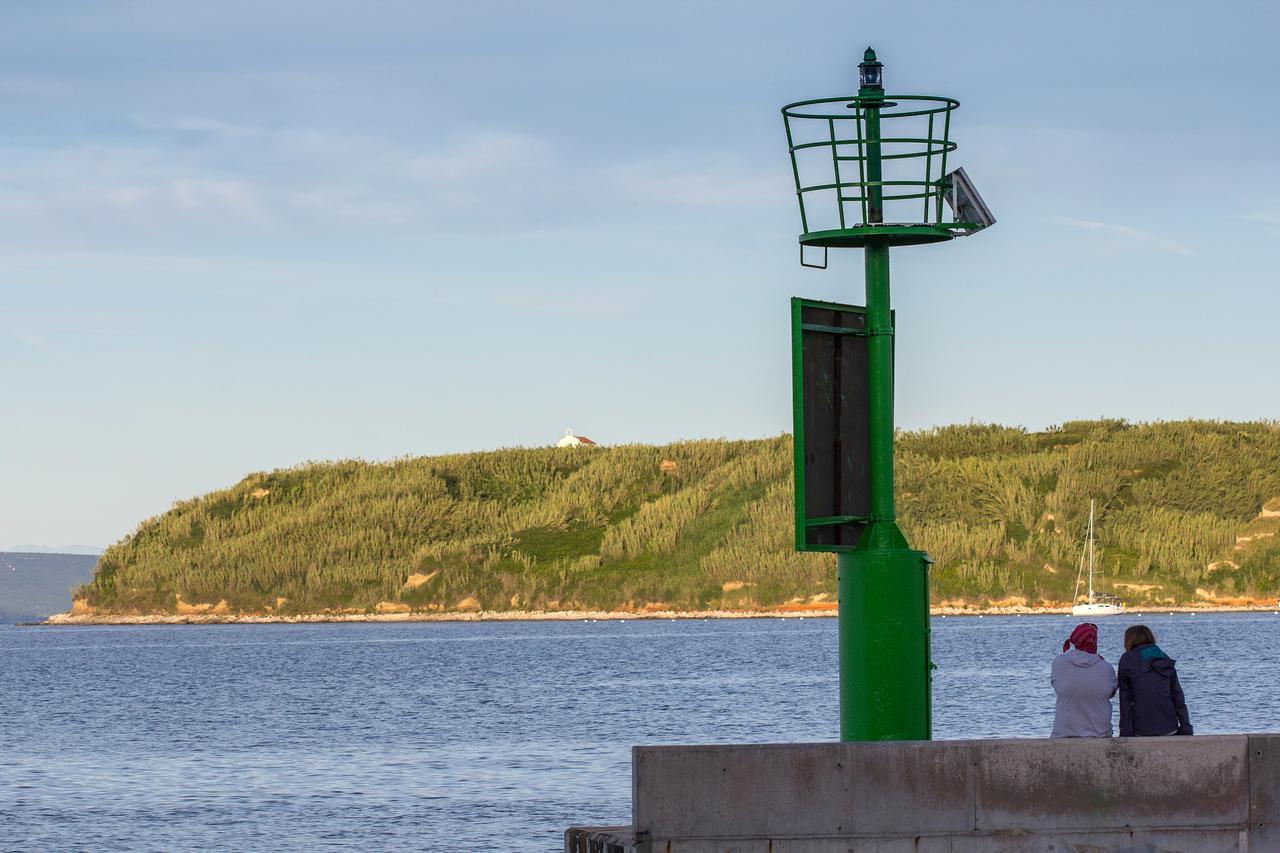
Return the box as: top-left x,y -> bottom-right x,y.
836,49 -> 932,740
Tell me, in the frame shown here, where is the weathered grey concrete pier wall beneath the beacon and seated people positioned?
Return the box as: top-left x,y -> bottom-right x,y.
564,735 -> 1280,853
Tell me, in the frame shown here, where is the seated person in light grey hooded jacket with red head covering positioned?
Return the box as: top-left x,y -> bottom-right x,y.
1048,622 -> 1116,738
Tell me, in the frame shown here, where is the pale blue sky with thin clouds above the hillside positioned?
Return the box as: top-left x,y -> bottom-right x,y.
0,0 -> 1280,547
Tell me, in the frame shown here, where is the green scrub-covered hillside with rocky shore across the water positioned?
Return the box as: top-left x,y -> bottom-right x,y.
78,421 -> 1280,613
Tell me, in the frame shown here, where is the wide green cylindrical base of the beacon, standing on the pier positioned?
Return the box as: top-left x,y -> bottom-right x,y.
836,548 -> 933,740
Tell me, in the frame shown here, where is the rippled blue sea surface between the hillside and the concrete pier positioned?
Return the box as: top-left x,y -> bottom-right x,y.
0,613 -> 1280,850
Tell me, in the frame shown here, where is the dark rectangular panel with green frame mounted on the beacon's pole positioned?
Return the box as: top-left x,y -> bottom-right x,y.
791,298 -> 870,551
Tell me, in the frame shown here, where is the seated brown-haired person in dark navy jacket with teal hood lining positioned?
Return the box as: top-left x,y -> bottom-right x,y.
1116,625 -> 1192,738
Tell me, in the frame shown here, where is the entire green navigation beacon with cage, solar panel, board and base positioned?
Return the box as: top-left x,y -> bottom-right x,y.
782,47 -> 995,740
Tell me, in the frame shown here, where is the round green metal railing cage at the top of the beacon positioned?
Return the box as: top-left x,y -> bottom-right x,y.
782,95 -> 973,252
